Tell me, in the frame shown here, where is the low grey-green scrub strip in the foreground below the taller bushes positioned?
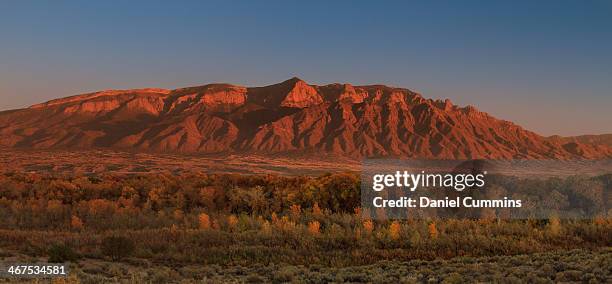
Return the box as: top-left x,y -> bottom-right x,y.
4,248 -> 612,283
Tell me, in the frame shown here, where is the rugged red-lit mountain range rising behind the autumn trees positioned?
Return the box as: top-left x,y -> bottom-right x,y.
0,78 -> 612,159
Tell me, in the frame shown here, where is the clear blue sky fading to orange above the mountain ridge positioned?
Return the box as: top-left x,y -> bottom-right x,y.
0,0 -> 612,135
